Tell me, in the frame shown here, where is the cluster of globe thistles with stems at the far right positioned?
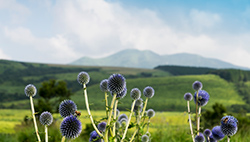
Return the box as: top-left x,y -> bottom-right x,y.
184,81 -> 238,142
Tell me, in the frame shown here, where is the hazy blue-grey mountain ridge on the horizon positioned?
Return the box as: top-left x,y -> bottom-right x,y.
70,49 -> 249,70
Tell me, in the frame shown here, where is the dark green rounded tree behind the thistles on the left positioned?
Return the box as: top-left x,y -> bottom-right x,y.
35,79 -> 73,114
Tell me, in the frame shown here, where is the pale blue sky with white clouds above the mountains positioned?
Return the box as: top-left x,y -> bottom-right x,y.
0,0 -> 250,67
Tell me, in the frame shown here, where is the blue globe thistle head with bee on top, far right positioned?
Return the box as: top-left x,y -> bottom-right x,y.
220,116 -> 238,136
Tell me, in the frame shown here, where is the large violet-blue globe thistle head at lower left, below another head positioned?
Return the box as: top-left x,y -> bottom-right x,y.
60,115 -> 82,139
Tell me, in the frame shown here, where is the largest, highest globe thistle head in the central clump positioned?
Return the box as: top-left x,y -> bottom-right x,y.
108,74 -> 126,94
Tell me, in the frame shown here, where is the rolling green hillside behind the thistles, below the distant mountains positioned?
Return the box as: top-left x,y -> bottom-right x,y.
0,60 -> 245,111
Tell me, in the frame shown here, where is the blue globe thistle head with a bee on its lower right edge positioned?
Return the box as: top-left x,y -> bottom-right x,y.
59,100 -> 77,117
